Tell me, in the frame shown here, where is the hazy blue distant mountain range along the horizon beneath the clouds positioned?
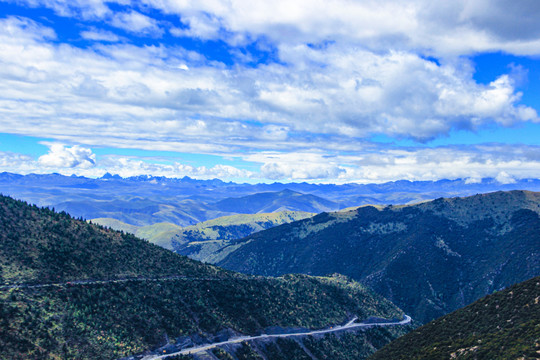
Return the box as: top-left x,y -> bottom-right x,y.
0,173 -> 540,226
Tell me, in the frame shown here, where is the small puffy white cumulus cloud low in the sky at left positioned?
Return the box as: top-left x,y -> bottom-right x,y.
38,144 -> 96,169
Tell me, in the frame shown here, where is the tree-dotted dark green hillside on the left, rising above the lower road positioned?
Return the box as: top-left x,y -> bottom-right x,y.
0,197 -> 403,359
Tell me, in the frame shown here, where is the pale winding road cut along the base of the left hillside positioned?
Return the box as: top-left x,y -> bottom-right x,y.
146,315 -> 412,360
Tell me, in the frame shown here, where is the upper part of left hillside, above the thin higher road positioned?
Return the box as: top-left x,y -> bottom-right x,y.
0,197 -> 219,284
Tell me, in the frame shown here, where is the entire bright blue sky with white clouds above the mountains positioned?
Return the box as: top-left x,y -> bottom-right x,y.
0,0 -> 540,183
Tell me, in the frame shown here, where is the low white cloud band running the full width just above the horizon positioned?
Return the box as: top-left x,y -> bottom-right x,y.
0,144 -> 540,184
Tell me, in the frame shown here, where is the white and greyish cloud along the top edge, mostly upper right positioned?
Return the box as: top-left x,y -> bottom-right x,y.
8,0 -> 540,56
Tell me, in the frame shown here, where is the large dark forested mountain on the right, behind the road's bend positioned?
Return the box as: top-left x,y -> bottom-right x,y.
217,191 -> 540,322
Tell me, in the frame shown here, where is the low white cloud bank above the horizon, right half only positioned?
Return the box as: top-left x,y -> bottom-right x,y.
244,145 -> 540,184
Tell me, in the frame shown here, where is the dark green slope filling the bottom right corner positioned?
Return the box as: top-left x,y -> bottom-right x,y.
370,277 -> 540,360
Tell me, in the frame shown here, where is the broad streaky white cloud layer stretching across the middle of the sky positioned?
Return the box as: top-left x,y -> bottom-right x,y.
0,17 -> 538,153
